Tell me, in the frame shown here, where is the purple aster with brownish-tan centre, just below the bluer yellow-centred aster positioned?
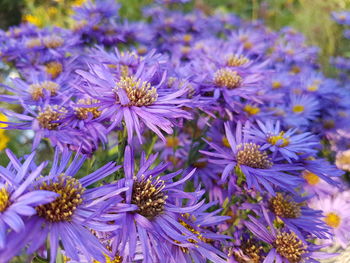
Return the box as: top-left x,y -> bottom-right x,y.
201,122 -> 303,194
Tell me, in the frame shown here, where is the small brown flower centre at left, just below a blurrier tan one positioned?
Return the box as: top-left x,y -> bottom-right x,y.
36,105 -> 67,130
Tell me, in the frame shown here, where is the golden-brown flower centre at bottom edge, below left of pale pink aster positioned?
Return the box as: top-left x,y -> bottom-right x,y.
273,232 -> 306,263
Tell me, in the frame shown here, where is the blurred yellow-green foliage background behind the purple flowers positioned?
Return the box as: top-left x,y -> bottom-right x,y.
0,0 -> 350,75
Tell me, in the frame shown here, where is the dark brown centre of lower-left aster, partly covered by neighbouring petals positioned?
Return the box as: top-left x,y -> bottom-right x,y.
35,174 -> 85,222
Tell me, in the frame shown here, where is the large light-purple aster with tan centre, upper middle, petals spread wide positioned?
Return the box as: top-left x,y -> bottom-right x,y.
77,58 -> 190,142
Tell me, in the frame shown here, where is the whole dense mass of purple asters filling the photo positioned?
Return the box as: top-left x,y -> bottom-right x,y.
0,0 -> 350,263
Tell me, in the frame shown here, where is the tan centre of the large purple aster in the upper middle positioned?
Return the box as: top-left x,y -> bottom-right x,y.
114,77 -> 158,107
